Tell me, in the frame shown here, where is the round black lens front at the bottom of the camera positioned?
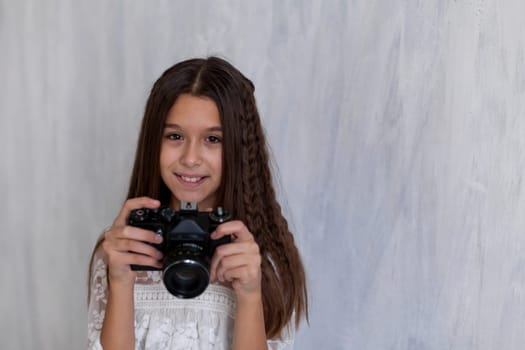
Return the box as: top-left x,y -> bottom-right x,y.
163,259 -> 210,298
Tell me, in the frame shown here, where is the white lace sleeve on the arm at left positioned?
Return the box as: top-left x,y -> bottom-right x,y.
88,249 -> 108,350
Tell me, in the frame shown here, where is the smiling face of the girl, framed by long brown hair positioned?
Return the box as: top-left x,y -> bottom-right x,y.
160,94 -> 223,210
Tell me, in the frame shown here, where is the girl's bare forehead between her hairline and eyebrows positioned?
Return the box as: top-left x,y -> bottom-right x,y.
166,94 -> 221,127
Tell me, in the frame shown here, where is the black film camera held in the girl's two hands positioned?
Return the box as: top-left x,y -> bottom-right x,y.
128,202 -> 231,298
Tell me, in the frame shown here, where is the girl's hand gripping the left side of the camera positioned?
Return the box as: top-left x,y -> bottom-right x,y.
102,197 -> 162,284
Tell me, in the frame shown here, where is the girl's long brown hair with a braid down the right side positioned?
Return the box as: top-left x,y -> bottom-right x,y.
86,57 -> 308,337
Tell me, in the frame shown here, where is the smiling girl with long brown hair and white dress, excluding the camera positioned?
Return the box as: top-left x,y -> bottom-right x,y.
88,57 -> 308,350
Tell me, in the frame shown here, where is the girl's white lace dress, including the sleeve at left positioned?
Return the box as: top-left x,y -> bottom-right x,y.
88,250 -> 294,350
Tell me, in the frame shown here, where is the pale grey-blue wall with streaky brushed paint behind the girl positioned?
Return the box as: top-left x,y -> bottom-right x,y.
0,0 -> 525,350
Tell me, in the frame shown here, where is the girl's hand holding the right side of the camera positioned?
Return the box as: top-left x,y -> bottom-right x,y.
210,220 -> 261,298
